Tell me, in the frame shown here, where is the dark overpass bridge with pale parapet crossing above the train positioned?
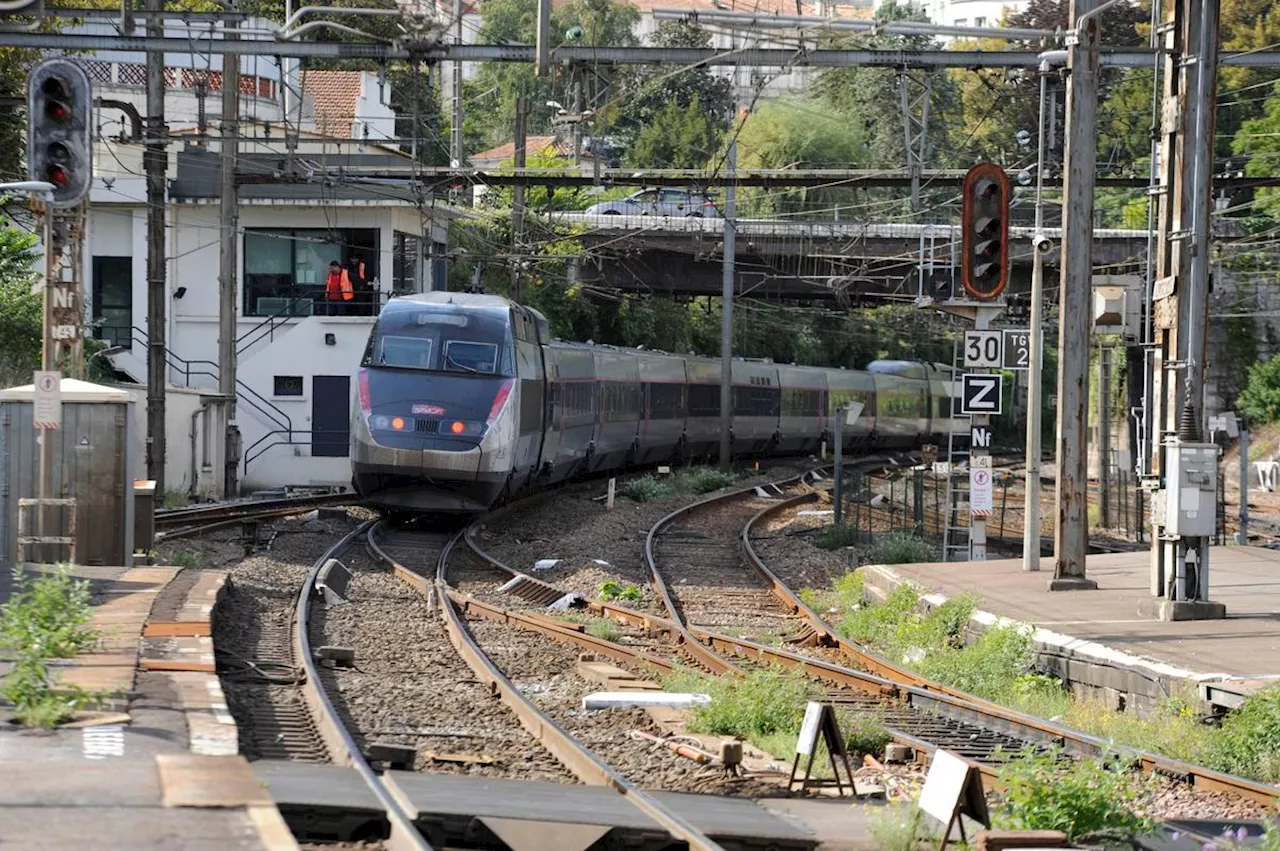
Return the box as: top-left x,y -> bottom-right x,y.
543,212 -> 1147,305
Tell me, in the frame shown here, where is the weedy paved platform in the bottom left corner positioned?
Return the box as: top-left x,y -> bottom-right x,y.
0,567 -> 297,851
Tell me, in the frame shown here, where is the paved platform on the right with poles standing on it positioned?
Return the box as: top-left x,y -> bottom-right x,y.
863,546 -> 1280,705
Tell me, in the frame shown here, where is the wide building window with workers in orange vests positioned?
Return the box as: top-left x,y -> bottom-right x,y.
243,228 -> 379,316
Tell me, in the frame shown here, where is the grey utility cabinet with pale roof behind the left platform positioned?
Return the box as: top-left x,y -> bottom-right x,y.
0,379 -> 134,567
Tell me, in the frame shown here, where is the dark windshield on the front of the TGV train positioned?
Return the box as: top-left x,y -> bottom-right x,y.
364,305 -> 515,376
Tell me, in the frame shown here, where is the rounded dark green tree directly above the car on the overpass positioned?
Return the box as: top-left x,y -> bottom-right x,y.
616,20 -> 733,168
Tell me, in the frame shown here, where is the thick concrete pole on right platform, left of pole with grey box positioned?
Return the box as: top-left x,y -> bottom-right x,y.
1050,0 -> 1098,591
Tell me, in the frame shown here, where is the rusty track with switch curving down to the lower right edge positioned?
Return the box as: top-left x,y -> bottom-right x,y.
447,459 -> 1280,807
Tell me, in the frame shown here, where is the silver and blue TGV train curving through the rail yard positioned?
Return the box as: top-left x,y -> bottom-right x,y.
352,293 -> 969,512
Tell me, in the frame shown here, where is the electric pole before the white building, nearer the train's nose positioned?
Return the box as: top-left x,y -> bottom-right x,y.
218,19 -> 239,499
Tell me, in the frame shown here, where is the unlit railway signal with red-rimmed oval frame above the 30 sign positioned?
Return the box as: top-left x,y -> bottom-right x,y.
960,163 -> 1010,301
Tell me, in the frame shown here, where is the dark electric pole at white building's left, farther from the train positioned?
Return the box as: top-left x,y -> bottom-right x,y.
142,0 -> 169,502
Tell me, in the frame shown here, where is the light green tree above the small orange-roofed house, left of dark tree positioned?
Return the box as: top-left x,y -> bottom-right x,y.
463,0 -> 640,145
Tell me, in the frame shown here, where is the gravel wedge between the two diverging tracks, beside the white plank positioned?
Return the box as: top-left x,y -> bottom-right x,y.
468,611 -> 782,796
